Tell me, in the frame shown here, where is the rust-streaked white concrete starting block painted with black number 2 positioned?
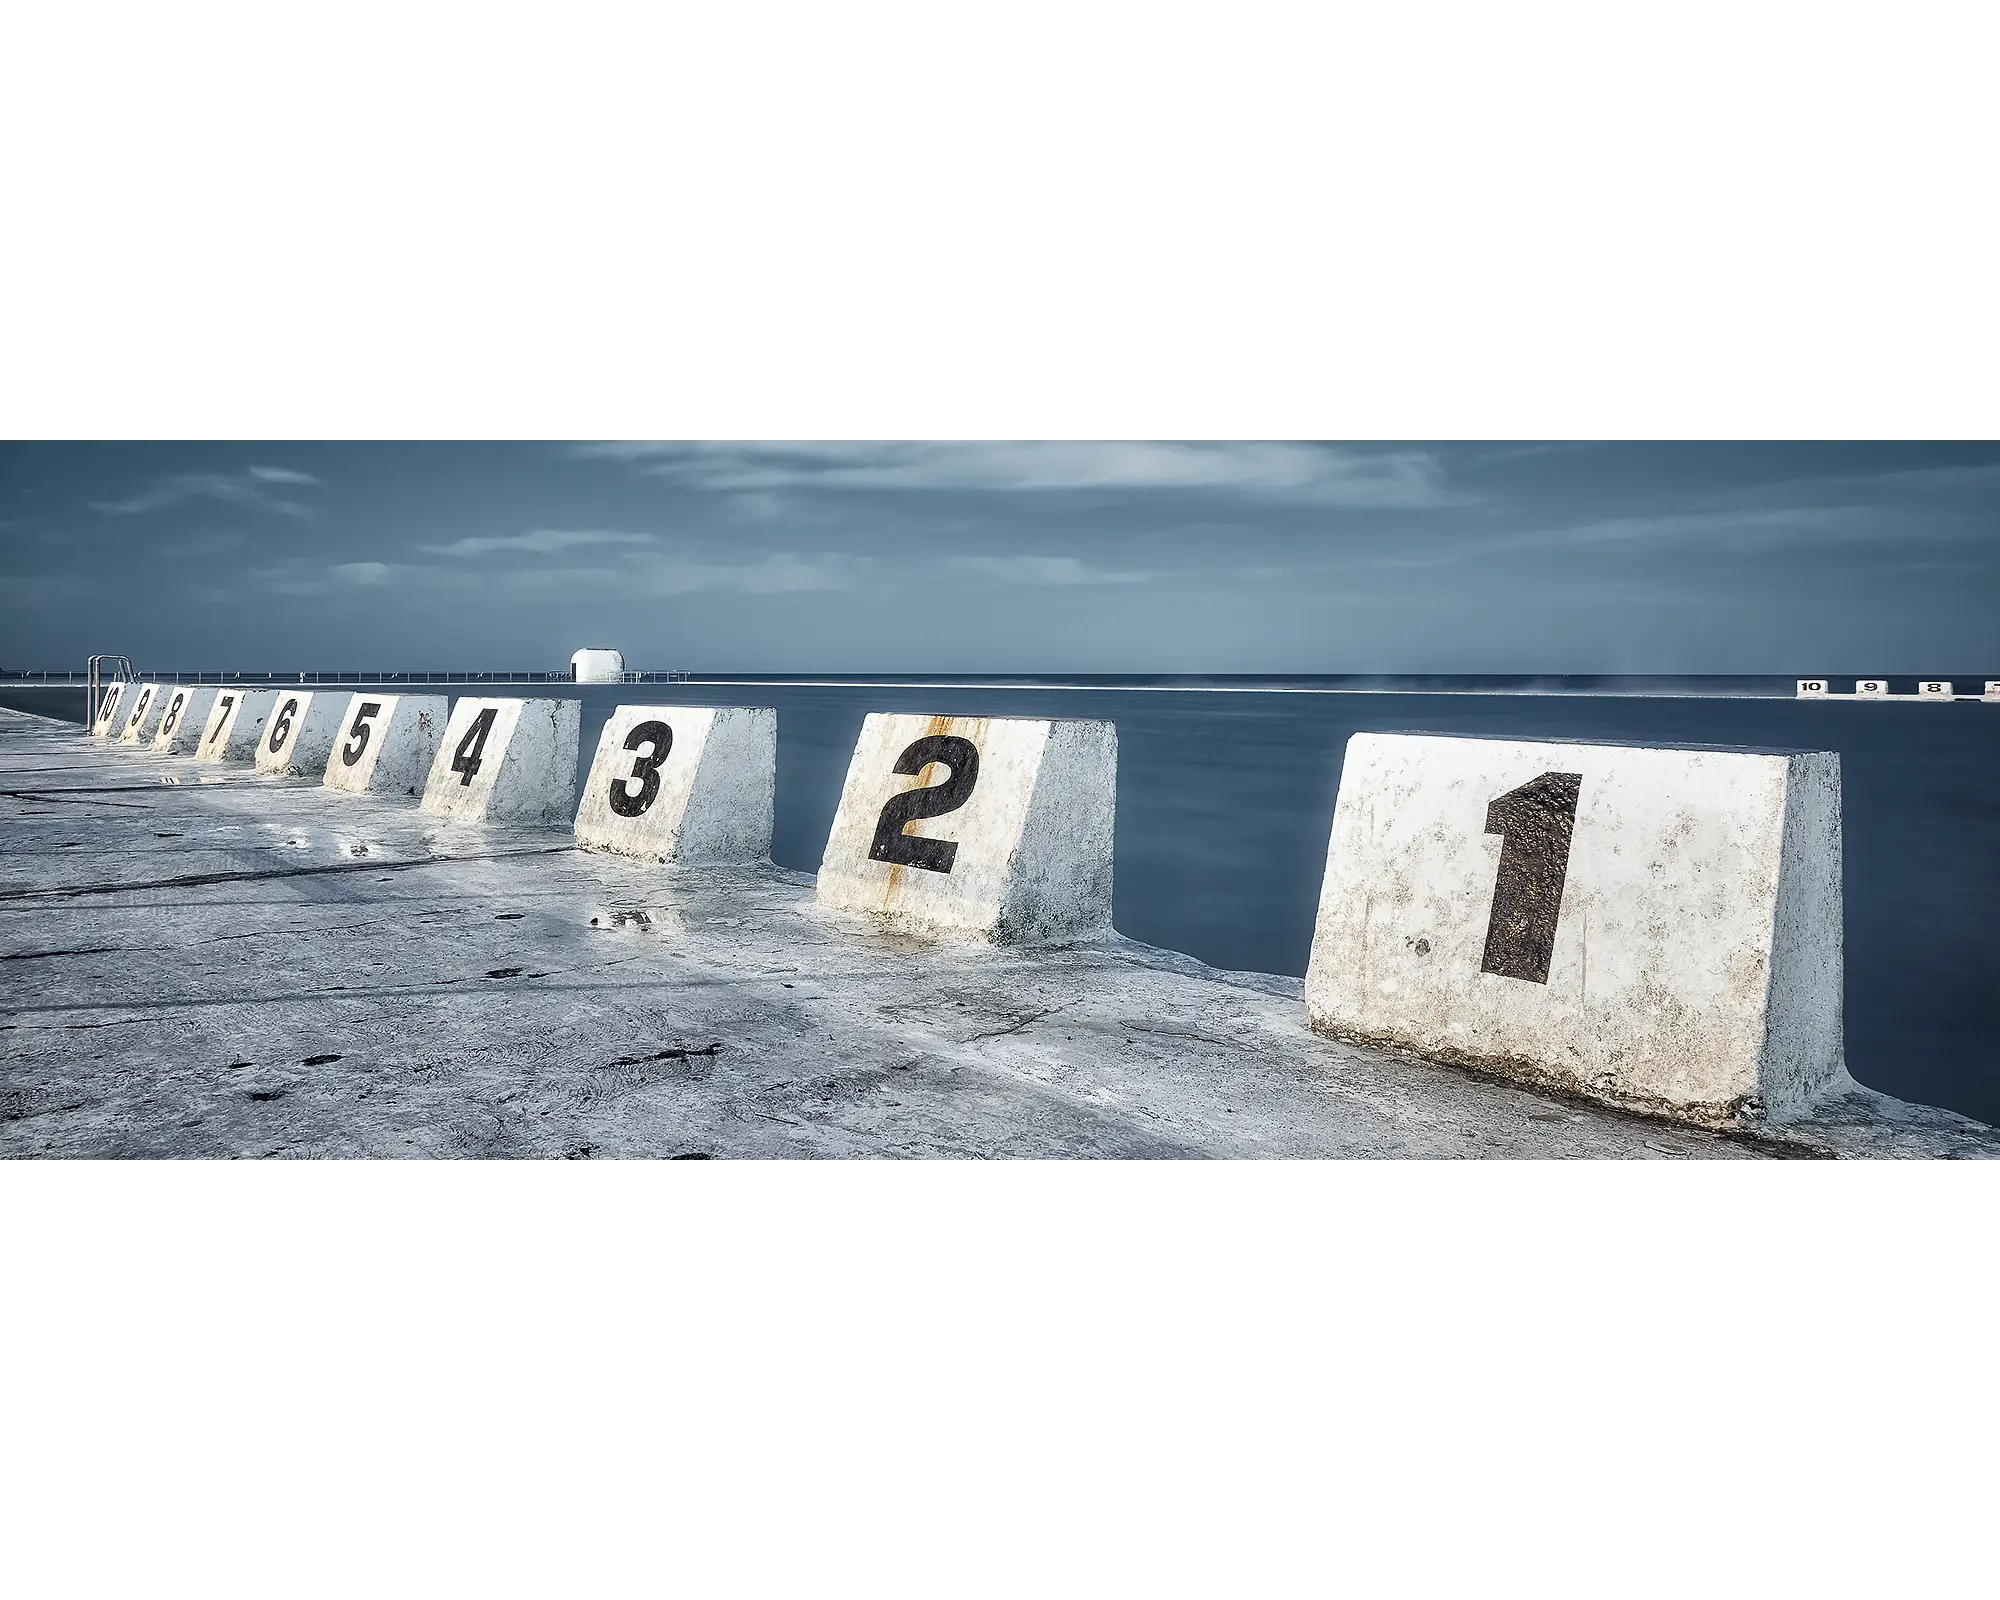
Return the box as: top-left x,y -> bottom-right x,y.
818,712 -> 1118,944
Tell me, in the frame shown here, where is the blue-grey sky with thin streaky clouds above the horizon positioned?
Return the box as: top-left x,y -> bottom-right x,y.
0,444 -> 2000,676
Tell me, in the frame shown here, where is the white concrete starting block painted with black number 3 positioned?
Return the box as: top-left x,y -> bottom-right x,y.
576,706 -> 778,864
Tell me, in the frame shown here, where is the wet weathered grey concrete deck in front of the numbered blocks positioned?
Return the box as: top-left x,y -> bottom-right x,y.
0,712 -> 2000,1158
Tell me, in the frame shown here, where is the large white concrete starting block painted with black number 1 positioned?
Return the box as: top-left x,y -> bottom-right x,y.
1306,734 -> 1852,1126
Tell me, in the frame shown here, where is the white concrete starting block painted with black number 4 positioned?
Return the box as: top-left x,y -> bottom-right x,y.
422,700 -> 580,824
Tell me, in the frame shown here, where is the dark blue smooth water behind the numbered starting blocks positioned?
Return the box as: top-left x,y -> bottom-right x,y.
0,678 -> 2000,1124
